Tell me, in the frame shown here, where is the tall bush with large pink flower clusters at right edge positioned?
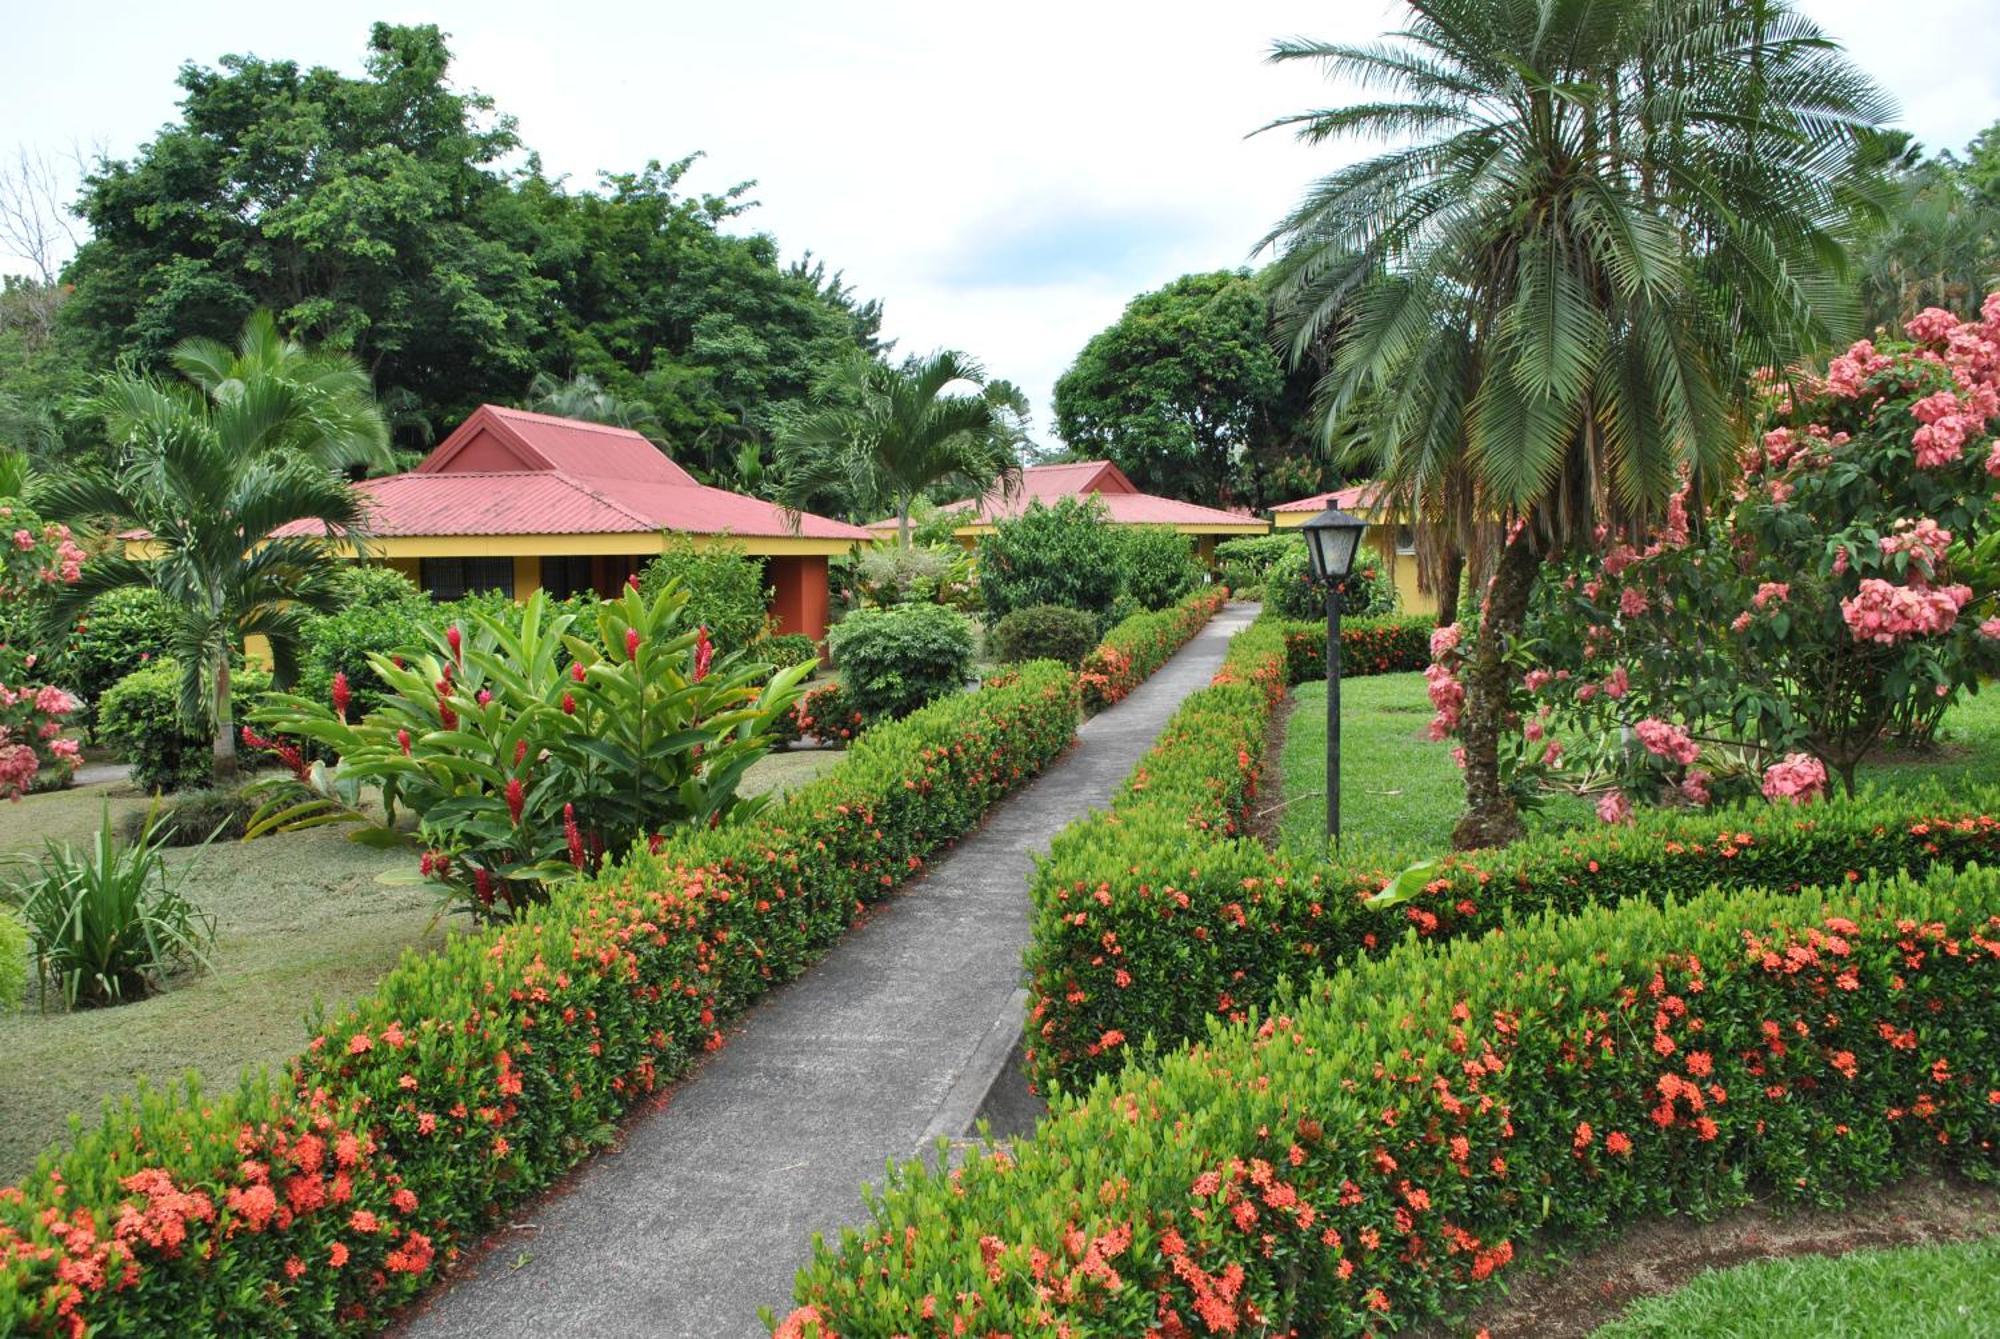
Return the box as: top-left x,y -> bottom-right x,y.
1510,294 -> 2000,807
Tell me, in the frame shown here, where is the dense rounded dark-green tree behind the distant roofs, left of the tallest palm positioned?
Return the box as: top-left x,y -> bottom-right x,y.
1054,270 -> 1310,506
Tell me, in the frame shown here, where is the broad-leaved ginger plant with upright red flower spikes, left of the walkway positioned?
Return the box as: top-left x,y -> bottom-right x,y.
246,586 -> 808,915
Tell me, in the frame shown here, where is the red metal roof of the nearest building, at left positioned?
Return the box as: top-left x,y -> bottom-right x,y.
280,404 -> 874,542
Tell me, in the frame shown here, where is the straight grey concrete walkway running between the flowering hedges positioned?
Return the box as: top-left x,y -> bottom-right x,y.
404,606 -> 1256,1339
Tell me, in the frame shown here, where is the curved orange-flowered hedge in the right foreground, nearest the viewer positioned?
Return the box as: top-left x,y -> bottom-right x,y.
778,869 -> 2000,1339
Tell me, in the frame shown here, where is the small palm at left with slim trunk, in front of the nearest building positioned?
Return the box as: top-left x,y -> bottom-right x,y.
43,318 -> 386,773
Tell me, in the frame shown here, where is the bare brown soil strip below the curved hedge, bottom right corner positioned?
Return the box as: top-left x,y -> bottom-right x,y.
1414,1177 -> 2000,1339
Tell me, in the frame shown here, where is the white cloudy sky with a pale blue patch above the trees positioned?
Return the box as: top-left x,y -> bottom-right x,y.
0,0 -> 2000,439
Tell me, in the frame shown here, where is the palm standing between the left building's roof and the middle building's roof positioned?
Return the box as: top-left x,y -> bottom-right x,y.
776,350 -> 1028,548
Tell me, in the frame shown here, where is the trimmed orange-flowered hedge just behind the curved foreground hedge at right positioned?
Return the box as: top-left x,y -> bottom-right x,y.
1028,783 -> 2000,1089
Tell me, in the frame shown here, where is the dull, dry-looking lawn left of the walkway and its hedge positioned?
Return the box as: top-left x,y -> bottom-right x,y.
0,749 -> 840,1185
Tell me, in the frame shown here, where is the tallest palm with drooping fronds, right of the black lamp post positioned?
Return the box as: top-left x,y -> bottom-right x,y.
1266,0 -> 1888,845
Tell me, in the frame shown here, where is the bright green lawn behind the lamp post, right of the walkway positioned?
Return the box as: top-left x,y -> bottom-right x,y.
1270,673 -> 2000,867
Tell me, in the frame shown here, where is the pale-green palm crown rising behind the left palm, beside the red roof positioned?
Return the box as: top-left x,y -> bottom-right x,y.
170,312 -> 396,474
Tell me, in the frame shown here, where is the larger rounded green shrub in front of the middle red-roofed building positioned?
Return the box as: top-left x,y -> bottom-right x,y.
978,498 -> 1120,620
